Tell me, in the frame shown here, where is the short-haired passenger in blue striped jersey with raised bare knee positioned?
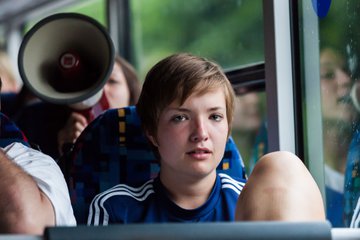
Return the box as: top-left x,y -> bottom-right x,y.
88,54 -> 325,225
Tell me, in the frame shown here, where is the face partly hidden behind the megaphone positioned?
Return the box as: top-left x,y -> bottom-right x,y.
104,63 -> 130,108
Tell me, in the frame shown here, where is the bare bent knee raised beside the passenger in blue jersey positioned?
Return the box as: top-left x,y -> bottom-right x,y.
236,151 -> 325,221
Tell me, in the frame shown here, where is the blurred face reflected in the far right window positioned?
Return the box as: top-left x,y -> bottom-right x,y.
320,50 -> 354,122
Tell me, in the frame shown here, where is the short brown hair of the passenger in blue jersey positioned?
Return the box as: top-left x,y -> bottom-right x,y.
137,53 -> 235,142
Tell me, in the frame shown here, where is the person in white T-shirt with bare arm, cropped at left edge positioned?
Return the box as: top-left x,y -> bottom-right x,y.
0,80 -> 76,234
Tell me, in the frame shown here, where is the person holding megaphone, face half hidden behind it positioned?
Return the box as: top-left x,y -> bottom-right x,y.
14,56 -> 140,159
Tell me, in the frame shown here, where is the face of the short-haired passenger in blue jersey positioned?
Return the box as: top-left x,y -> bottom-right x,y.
150,88 -> 228,179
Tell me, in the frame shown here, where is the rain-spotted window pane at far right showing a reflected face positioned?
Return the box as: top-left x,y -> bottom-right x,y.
319,0 -> 360,227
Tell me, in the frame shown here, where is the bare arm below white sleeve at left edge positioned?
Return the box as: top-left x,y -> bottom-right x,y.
0,148 -> 55,234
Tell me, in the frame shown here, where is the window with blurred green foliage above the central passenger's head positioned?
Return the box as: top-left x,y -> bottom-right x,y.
131,0 -> 264,79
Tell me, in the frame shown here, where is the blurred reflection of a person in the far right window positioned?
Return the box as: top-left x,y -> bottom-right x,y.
320,47 -> 358,227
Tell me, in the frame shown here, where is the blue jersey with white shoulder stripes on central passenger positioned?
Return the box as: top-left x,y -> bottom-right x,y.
88,173 -> 246,225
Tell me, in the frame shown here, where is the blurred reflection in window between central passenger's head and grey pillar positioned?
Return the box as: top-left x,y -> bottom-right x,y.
232,88 -> 267,175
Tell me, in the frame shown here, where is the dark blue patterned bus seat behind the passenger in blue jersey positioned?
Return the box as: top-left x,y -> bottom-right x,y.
60,106 -> 246,224
